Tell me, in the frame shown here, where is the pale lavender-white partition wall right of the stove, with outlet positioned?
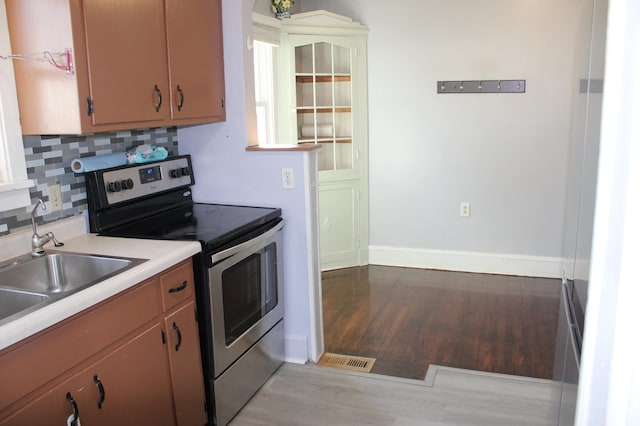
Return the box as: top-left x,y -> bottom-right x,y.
178,0 -> 323,362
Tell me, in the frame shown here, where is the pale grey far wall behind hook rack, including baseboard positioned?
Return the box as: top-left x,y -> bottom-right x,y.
302,0 -> 584,276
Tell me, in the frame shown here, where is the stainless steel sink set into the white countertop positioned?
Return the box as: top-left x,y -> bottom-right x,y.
0,253 -> 145,324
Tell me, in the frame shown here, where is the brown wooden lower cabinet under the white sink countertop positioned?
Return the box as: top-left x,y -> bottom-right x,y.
0,261 -> 206,426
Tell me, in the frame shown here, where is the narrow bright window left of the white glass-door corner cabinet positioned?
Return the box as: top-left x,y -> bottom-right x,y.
253,40 -> 276,145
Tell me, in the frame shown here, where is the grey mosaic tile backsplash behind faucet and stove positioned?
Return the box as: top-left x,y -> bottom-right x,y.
0,127 -> 179,236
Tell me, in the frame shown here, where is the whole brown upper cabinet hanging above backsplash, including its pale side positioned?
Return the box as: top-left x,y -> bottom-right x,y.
6,0 -> 225,134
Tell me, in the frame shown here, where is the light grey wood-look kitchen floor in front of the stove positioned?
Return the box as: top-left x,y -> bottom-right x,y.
231,363 -> 558,426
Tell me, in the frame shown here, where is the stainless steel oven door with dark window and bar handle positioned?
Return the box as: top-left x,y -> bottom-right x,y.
209,221 -> 284,377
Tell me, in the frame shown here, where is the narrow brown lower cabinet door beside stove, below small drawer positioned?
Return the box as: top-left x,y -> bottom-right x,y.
165,302 -> 207,426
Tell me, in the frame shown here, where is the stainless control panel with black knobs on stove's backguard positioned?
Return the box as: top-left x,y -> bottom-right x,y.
100,156 -> 194,205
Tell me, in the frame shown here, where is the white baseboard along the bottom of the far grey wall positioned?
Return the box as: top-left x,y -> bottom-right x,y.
369,246 -> 566,278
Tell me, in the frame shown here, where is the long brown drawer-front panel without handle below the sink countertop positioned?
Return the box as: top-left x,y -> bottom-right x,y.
0,279 -> 160,417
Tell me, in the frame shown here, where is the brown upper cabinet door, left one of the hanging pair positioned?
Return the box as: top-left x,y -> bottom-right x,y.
83,0 -> 169,125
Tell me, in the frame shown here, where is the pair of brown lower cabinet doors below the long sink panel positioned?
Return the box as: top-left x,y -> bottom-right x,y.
0,324 -> 174,426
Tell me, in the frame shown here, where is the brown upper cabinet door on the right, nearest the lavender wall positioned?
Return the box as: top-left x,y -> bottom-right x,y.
166,0 -> 225,121
